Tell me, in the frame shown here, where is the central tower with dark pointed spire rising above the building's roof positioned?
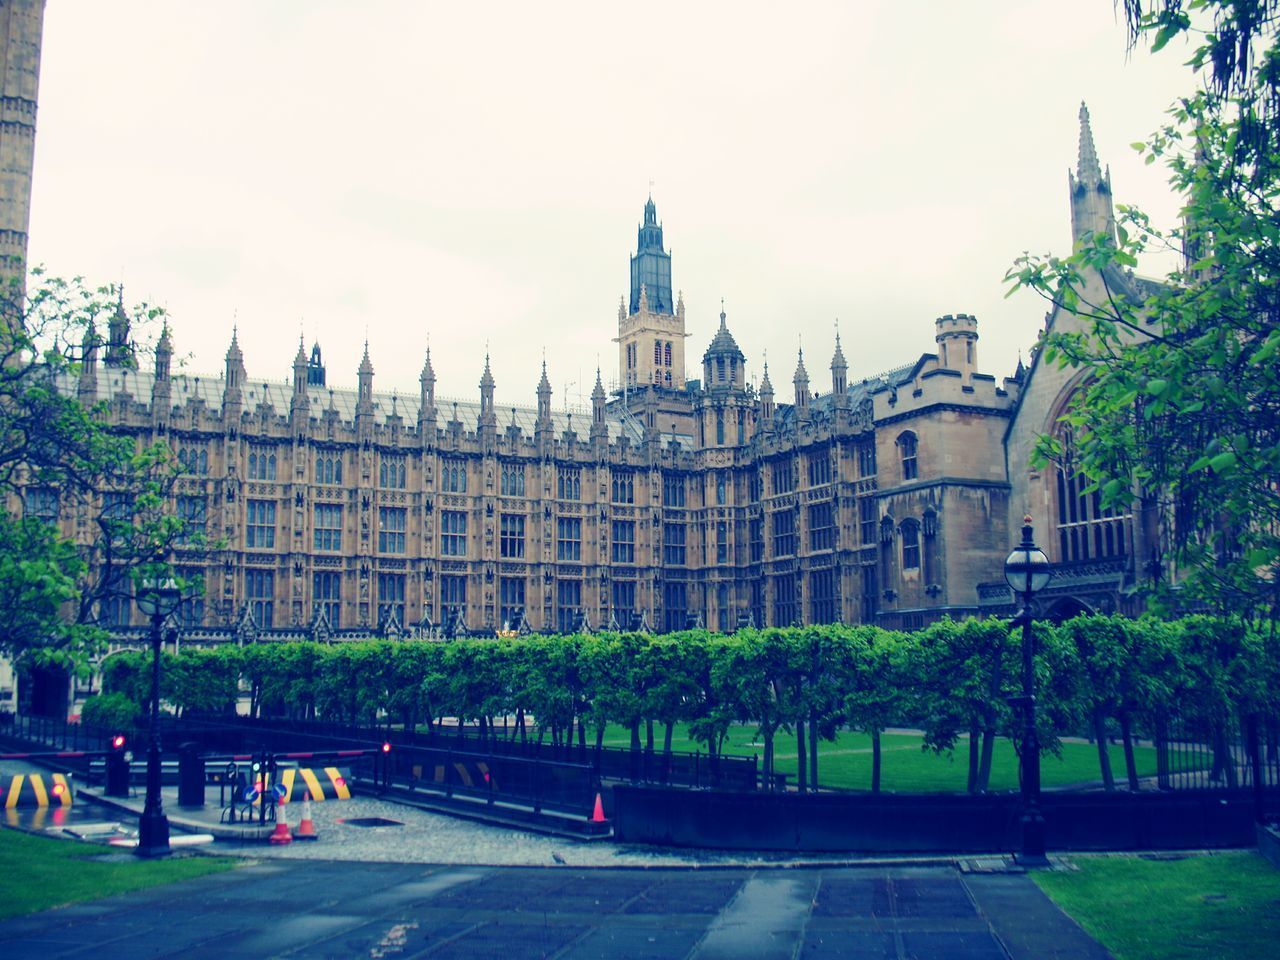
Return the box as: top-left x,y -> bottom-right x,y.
617,197 -> 685,392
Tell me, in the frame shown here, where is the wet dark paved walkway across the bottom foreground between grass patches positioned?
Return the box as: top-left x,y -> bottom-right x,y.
0,860 -> 1107,960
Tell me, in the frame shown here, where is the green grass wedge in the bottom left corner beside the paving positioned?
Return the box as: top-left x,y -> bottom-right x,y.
0,827 -> 238,919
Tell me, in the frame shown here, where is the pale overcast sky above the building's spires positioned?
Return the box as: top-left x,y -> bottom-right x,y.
31,0 -> 1192,408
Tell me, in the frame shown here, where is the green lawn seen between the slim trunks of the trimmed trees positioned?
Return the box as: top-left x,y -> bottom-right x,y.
593,726 -> 1156,792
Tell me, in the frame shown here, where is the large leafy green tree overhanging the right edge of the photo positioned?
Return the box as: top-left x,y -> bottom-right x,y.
1009,7 -> 1280,617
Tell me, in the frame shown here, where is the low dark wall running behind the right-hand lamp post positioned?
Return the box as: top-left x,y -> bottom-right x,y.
613,786 -> 1280,854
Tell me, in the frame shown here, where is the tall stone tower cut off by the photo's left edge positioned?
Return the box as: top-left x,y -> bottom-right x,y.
0,0 -> 45,323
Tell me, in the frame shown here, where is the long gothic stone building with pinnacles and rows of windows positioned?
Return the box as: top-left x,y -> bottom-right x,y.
28,110 -> 1152,647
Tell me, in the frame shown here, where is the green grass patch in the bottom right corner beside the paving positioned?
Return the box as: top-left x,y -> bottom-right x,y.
1032,852 -> 1280,960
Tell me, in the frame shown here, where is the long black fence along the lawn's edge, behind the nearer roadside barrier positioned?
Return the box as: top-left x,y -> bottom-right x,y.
170,717 -> 759,790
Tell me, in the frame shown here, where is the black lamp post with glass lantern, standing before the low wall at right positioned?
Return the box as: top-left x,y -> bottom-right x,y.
1005,516 -> 1053,867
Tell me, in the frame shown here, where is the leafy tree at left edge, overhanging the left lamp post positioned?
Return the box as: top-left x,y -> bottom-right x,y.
0,270 -> 192,666
